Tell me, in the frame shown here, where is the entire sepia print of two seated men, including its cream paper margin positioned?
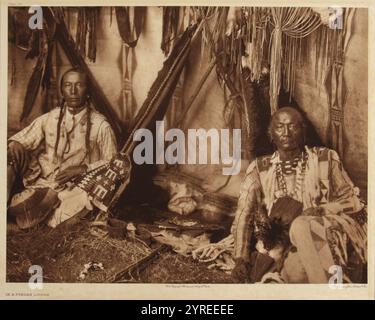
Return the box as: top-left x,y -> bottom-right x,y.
1,1 -> 374,298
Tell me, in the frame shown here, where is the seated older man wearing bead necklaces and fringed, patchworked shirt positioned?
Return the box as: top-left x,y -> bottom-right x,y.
232,107 -> 367,283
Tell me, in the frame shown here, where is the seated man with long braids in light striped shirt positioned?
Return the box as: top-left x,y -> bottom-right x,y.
7,68 -> 117,229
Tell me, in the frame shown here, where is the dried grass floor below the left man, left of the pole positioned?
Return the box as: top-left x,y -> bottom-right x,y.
7,223 -> 149,283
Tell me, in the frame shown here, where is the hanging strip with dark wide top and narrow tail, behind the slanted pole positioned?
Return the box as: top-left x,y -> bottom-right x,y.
115,7 -> 146,121
